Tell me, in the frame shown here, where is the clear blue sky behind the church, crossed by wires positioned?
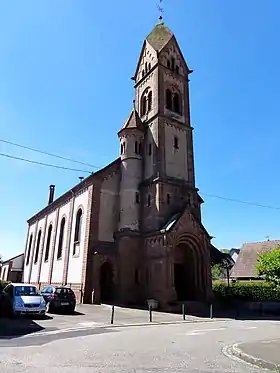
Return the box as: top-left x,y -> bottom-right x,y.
0,0 -> 280,258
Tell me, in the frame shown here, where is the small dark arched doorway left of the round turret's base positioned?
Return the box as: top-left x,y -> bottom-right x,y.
99,261 -> 114,303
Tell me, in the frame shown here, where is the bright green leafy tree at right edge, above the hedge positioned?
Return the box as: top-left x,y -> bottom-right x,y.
256,247 -> 280,286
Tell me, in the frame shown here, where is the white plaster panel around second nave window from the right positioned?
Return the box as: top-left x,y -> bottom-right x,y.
52,201 -> 71,283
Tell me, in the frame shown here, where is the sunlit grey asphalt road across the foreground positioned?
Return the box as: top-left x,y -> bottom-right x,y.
0,321 -> 280,373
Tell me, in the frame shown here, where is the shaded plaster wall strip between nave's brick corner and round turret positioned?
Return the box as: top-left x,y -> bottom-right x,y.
98,173 -> 120,242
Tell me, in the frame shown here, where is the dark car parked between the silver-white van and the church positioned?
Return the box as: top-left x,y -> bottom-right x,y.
41,285 -> 76,313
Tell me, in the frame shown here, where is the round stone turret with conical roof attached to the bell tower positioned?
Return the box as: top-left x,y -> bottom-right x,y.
118,110 -> 144,231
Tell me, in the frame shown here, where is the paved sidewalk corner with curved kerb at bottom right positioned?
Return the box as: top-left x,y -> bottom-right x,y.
232,339 -> 280,372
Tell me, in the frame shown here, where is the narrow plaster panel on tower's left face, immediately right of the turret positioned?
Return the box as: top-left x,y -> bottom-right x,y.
144,121 -> 158,179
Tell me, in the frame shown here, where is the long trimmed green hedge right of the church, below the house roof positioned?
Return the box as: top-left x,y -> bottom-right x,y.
212,282 -> 280,302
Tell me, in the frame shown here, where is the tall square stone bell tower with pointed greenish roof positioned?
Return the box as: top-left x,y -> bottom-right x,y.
133,17 -> 203,232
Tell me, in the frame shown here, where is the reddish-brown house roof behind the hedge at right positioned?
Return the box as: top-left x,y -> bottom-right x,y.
230,240 -> 280,278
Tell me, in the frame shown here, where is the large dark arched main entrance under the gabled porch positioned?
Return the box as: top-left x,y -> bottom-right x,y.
173,235 -> 206,301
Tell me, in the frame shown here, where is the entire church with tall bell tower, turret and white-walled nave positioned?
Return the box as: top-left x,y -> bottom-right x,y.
23,19 -> 213,310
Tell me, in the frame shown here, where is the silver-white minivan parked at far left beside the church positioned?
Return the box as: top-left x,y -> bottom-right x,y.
1,283 -> 46,316
